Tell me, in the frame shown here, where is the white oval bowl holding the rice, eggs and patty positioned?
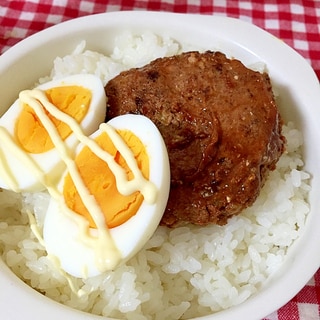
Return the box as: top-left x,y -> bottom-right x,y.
0,11 -> 320,320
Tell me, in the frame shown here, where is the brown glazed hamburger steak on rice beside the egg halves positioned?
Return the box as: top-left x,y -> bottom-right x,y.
105,51 -> 284,227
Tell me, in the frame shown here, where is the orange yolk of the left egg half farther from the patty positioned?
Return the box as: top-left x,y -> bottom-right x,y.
15,86 -> 91,153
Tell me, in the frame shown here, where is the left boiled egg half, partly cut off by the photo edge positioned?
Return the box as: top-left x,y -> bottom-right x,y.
0,74 -> 106,192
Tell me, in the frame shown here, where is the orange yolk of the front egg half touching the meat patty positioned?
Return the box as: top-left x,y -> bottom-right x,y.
63,130 -> 149,228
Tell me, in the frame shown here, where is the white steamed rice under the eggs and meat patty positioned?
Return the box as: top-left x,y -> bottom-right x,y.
0,33 -> 310,320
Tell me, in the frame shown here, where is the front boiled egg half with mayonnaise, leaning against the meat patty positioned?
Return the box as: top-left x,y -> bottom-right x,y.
43,115 -> 170,278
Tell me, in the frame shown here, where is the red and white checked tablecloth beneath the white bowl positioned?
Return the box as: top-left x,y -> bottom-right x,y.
0,0 -> 320,320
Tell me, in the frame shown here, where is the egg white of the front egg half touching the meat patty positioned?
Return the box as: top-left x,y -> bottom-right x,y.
43,115 -> 170,278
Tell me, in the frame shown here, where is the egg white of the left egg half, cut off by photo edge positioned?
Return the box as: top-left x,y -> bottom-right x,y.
0,74 -> 106,192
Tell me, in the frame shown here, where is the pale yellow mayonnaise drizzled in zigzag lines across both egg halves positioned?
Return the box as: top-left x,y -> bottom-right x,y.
0,89 -> 157,272
